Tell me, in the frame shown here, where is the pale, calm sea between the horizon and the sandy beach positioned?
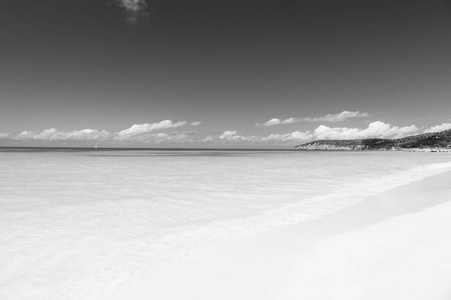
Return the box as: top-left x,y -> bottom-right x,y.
0,148 -> 451,300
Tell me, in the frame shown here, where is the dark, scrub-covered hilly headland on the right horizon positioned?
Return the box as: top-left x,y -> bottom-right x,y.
294,129 -> 451,151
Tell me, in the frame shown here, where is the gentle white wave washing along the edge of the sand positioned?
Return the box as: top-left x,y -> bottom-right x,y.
130,163 -> 451,280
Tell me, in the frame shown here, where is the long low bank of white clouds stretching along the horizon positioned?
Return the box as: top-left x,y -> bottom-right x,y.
0,120 -> 424,145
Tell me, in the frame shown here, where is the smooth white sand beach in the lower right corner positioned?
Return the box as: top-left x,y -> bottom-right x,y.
101,172 -> 451,300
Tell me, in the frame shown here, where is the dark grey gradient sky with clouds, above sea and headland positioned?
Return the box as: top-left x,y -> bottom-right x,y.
0,0 -> 451,149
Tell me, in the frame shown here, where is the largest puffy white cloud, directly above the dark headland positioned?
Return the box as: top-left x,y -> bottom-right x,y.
314,121 -> 418,140
